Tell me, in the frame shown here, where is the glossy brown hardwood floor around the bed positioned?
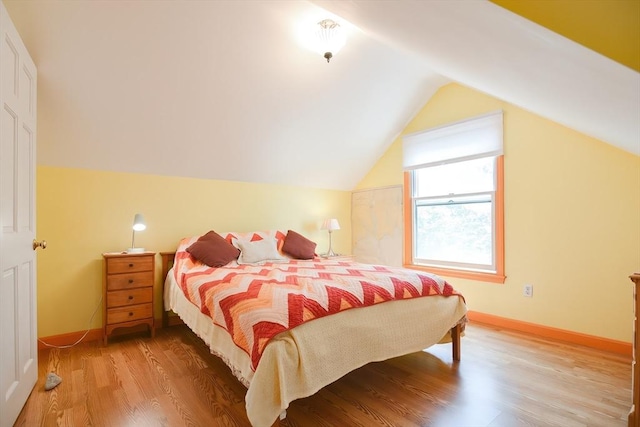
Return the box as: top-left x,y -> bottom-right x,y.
16,324 -> 631,427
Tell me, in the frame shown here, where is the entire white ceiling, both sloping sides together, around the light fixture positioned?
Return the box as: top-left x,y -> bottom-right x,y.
4,0 -> 640,190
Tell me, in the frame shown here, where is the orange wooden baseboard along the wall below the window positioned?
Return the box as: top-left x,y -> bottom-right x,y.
467,311 -> 633,358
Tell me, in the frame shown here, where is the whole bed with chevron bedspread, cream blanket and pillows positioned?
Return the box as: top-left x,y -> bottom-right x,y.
162,230 -> 466,426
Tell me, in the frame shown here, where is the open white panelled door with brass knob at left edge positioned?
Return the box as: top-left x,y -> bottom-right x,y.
0,2 -> 38,427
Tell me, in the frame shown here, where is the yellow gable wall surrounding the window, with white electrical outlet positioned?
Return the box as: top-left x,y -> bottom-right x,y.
358,84 -> 640,342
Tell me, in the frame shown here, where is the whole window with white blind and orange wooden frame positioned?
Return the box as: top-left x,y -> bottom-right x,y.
403,112 -> 504,283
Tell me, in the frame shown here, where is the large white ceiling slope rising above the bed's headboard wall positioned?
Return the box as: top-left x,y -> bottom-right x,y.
6,1 -> 446,190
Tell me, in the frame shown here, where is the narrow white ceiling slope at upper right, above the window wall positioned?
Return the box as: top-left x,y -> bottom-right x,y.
314,0 -> 640,159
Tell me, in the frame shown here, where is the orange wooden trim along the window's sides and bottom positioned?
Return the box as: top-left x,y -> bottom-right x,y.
403,155 -> 506,283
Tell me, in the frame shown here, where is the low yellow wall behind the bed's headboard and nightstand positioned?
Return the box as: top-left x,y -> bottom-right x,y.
36,166 -> 351,337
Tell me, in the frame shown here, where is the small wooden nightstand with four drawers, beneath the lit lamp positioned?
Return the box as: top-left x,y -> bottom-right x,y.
102,252 -> 156,345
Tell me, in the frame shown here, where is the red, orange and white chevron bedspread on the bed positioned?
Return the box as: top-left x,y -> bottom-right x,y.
174,233 -> 463,371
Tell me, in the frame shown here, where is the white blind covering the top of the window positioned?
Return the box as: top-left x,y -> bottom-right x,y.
402,111 -> 502,170
